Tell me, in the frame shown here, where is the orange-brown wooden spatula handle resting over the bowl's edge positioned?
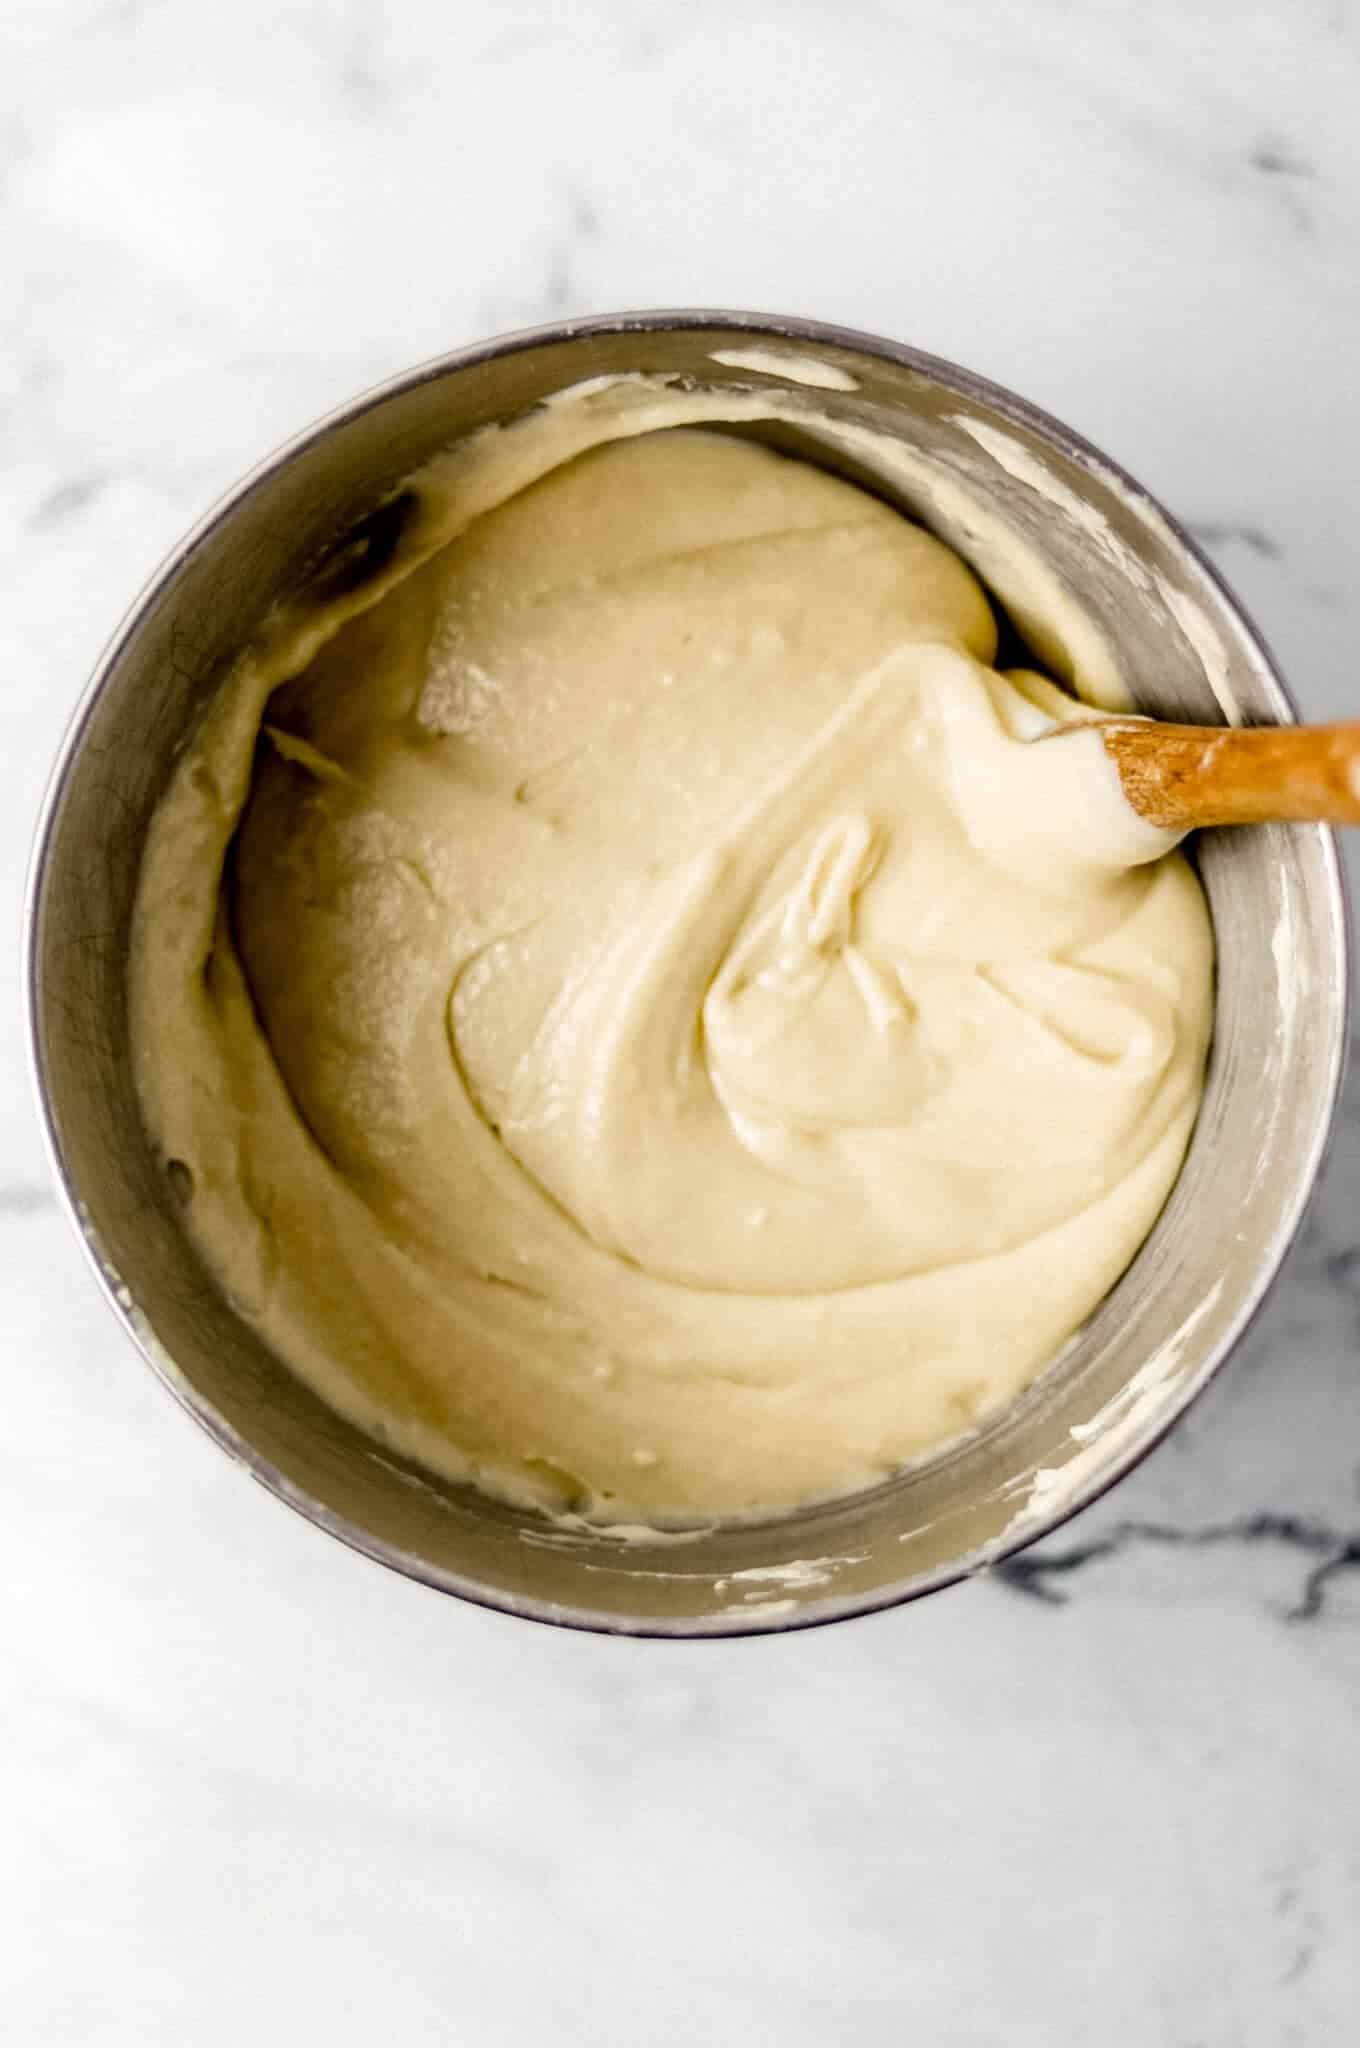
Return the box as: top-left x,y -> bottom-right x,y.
1100,719 -> 1360,831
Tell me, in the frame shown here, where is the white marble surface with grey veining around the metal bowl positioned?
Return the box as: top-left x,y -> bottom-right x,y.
0,0 -> 1360,2048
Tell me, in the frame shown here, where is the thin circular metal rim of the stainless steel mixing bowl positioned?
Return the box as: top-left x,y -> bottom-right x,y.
20,307 -> 1354,1640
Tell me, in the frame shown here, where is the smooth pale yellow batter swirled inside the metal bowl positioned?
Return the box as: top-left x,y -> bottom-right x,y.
133,389 -> 1213,1522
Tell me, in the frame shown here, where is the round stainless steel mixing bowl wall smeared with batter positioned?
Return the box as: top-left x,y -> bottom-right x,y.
29,311 -> 1348,1636
